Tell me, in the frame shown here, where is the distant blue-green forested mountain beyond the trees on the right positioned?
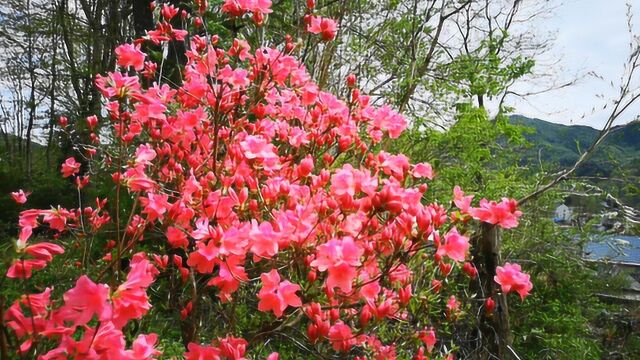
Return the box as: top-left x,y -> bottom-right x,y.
510,115 -> 640,207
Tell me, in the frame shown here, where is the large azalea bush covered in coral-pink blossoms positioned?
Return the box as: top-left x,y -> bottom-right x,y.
2,0 -> 532,359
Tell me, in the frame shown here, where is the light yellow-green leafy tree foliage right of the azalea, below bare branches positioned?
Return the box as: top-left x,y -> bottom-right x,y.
398,104 -> 533,202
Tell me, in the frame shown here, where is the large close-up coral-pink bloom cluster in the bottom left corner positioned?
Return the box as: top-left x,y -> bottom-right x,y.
4,253 -> 160,360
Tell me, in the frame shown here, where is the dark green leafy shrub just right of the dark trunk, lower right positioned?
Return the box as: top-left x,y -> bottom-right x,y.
504,218 -> 606,359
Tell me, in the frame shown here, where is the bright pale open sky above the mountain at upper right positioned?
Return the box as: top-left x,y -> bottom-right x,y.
511,0 -> 640,128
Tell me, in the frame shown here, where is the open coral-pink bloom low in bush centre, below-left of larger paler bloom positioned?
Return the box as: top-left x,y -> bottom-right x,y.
258,269 -> 302,318
